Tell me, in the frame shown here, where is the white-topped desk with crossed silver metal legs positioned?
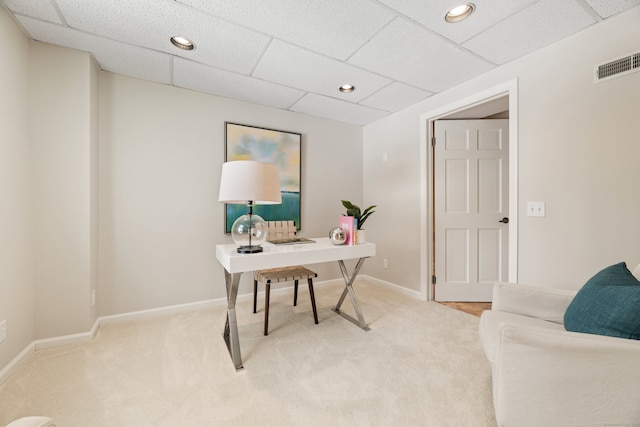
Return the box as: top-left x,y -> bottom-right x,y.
216,237 -> 376,370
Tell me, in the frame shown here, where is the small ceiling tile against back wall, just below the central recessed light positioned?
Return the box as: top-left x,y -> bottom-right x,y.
289,93 -> 389,126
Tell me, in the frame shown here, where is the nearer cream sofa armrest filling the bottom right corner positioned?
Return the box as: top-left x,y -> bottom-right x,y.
493,322 -> 640,427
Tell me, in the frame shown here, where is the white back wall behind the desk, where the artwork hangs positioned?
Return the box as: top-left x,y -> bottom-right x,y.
99,73 -> 362,315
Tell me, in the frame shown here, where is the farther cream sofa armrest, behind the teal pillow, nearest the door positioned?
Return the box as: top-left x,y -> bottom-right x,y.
491,283 -> 577,324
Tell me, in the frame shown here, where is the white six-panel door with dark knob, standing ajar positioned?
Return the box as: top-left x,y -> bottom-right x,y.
433,119 -> 509,301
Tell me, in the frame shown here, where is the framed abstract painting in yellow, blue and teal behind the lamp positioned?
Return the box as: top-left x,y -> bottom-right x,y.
224,122 -> 302,233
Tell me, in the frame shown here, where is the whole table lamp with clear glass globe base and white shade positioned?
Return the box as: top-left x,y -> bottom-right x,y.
218,160 -> 282,253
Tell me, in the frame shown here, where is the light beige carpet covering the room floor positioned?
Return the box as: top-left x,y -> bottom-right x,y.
0,279 -> 496,427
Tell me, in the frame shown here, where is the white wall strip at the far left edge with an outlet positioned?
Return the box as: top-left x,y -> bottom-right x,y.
0,8 -> 35,370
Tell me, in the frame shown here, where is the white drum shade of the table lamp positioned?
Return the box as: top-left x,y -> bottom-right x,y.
218,160 -> 282,205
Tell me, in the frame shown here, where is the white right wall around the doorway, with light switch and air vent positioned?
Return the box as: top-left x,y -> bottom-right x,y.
363,8 -> 640,292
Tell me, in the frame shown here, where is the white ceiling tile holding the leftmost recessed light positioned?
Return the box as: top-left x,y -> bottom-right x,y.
52,0 -> 269,74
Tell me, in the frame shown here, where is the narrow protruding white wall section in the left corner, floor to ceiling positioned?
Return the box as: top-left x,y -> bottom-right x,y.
30,42 -> 98,338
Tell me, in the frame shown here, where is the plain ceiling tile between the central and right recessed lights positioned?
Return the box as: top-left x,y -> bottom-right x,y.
348,18 -> 494,92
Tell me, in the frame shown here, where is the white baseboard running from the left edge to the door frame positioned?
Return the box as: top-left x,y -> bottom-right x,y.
0,275 -> 418,385
